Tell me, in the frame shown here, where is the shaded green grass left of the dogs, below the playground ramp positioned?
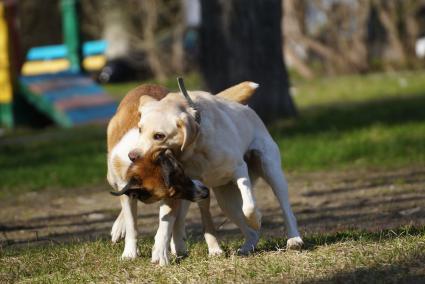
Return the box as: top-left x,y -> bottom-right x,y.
0,127 -> 106,197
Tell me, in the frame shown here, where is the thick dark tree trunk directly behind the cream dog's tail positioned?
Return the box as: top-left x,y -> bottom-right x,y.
200,0 -> 296,122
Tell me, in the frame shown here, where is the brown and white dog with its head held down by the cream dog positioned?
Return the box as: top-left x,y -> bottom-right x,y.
107,85 -> 208,258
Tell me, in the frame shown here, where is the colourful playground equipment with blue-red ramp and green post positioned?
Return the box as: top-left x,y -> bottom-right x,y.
0,0 -> 117,127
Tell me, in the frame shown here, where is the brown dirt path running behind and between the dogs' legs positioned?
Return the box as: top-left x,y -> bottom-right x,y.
0,168 -> 425,246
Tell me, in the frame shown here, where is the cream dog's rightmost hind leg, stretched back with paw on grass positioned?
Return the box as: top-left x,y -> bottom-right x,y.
254,141 -> 303,249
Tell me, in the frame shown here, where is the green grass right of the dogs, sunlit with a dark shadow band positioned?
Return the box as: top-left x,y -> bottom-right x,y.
271,72 -> 425,171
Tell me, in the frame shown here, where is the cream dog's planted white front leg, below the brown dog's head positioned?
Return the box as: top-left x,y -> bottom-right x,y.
152,199 -> 181,266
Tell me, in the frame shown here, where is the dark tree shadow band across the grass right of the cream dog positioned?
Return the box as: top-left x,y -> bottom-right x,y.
271,95 -> 425,137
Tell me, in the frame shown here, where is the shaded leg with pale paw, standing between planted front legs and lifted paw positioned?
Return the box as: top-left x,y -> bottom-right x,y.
198,197 -> 223,256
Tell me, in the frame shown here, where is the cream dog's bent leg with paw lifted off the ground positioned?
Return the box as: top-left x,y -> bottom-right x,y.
235,162 -> 261,230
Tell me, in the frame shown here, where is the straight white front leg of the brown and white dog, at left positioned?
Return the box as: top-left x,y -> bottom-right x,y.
120,195 -> 139,259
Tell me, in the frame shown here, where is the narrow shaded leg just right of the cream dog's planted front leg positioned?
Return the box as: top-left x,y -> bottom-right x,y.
170,200 -> 190,256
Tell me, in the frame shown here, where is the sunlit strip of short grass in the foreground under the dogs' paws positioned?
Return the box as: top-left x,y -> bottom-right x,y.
0,227 -> 425,283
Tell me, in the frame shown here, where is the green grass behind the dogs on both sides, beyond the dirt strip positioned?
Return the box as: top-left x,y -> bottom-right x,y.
0,72 -> 425,195
